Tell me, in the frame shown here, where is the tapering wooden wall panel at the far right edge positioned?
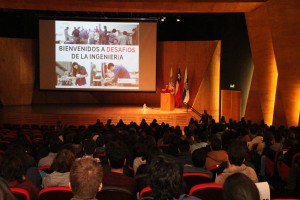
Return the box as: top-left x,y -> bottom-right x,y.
267,0 -> 300,126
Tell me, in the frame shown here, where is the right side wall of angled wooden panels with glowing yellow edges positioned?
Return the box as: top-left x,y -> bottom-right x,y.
245,0 -> 300,126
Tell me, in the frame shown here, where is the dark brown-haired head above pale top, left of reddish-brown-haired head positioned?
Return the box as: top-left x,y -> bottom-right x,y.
52,149 -> 75,173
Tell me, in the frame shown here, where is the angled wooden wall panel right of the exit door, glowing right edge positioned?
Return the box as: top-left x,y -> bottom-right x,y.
245,7 -> 278,125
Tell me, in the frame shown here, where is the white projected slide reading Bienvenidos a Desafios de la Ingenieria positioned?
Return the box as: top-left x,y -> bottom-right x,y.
53,21 -> 139,89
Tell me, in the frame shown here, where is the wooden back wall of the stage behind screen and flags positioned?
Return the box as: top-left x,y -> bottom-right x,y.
0,38 -> 219,111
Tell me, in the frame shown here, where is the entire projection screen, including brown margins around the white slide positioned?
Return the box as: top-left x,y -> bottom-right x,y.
39,19 -> 157,92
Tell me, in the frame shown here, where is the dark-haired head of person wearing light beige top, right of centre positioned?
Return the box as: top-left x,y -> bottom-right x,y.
227,142 -> 247,166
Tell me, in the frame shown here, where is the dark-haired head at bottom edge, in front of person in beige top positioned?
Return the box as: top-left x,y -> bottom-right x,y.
223,173 -> 260,200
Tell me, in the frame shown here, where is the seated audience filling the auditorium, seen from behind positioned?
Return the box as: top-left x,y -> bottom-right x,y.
0,115 -> 300,200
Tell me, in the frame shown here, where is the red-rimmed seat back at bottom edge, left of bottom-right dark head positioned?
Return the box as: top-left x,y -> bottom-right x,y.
189,183 -> 223,200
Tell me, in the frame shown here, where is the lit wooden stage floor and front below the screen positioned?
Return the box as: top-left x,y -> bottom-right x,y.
0,104 -> 197,128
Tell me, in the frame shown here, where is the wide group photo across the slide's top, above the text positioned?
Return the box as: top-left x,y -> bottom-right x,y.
55,21 -> 139,45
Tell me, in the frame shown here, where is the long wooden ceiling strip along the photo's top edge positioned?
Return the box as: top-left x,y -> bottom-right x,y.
0,0 -> 268,13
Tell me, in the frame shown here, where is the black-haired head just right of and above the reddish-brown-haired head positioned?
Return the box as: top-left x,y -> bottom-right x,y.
106,147 -> 126,169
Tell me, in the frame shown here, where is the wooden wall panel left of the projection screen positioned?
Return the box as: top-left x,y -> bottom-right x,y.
0,39 -> 37,105
